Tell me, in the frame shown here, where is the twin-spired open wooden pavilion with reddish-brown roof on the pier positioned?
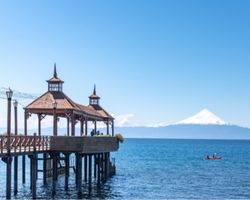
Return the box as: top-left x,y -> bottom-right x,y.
24,64 -> 114,136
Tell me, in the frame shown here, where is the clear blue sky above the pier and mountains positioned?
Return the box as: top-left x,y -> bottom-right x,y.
0,0 -> 250,127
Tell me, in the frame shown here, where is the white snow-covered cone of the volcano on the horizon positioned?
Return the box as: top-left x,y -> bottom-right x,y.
176,109 -> 228,125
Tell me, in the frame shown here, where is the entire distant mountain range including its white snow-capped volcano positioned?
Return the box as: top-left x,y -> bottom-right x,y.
116,109 -> 250,139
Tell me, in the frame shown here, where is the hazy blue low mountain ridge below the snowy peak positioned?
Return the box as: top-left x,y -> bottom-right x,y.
116,125 -> 250,139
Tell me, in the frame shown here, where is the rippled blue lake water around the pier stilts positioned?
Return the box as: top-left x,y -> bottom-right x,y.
0,139 -> 250,199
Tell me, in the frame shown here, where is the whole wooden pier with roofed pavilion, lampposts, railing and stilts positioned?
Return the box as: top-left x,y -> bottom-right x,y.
0,66 -> 119,199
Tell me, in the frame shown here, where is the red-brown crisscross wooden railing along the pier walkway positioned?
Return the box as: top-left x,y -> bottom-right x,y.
0,135 -> 50,154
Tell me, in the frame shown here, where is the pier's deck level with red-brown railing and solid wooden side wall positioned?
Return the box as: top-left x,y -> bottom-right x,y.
0,136 -> 119,158
